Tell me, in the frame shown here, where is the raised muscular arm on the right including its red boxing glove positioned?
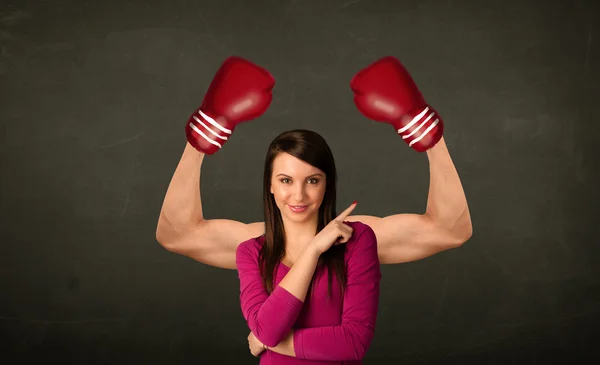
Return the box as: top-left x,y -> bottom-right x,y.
349,57 -> 472,264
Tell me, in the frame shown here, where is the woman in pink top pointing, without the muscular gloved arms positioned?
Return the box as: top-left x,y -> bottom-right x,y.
236,130 -> 381,365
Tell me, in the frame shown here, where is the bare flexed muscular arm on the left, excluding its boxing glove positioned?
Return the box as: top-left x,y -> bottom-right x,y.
156,143 -> 264,269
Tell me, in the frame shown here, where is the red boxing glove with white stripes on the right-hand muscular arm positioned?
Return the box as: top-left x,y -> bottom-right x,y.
350,56 -> 444,152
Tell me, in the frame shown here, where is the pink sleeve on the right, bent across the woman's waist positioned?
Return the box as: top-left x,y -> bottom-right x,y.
294,226 -> 381,361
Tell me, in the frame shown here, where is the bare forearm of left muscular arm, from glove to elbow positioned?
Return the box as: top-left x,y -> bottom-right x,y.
156,143 -> 204,244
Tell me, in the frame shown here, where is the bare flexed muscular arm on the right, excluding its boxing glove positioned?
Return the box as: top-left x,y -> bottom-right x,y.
348,138 -> 472,264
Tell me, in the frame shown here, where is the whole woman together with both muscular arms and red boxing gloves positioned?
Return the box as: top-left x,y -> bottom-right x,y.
156,57 -> 471,364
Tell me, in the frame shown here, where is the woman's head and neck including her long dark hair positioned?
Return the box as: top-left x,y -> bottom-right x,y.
261,130 -> 344,289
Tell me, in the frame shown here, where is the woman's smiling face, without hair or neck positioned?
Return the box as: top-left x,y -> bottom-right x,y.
271,153 -> 326,223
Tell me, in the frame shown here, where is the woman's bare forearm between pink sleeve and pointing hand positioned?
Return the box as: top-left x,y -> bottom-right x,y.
279,244 -> 320,302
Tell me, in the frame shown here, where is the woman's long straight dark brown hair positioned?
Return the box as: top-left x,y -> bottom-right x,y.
259,129 -> 346,295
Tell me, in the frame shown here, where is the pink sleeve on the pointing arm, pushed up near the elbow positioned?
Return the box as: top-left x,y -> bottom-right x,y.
236,240 -> 302,347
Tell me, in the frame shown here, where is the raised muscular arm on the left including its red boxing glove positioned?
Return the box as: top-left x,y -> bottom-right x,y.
156,57 -> 275,269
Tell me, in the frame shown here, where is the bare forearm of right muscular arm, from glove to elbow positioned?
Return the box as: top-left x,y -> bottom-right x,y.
426,138 -> 472,239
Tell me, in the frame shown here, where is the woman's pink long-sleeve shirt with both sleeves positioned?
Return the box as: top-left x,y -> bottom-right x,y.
236,222 -> 381,365
